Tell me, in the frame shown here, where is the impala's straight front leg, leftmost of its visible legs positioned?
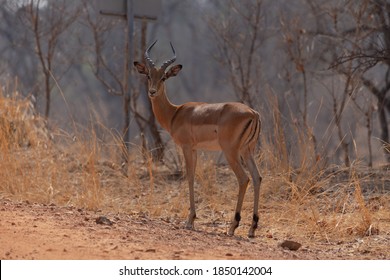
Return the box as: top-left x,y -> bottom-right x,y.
183,147 -> 197,229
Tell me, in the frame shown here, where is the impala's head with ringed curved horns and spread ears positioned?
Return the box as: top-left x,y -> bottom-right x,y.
134,40 -> 183,98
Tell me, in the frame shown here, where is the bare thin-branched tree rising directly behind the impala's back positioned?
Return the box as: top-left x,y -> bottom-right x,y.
207,0 -> 264,106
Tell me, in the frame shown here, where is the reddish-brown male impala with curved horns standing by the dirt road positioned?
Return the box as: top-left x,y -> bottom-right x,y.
134,41 -> 262,237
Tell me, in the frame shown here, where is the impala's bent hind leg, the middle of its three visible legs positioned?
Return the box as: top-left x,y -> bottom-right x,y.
225,153 -> 249,235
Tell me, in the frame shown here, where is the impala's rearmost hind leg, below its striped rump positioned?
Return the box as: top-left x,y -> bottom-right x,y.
244,151 -> 262,237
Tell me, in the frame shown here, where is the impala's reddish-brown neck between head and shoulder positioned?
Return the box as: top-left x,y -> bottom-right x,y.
150,85 -> 177,132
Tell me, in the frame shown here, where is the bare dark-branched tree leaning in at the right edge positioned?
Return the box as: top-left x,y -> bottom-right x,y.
308,0 -> 390,162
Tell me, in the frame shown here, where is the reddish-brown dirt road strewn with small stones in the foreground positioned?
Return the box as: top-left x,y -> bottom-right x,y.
0,199 -> 390,260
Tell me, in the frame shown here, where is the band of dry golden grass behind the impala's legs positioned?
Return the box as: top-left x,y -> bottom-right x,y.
0,85 -> 390,249
